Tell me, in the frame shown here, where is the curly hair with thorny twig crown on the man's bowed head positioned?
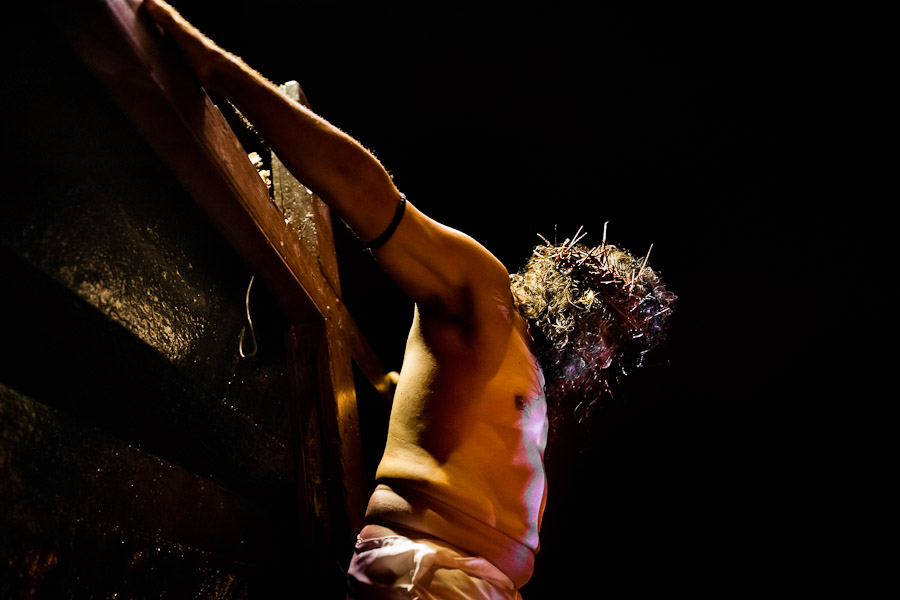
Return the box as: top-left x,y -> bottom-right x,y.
510,229 -> 675,430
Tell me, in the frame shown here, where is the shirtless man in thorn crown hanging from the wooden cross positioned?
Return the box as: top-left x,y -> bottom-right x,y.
144,0 -> 671,599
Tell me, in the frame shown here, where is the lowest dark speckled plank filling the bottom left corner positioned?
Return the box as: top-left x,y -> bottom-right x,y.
0,385 -> 307,598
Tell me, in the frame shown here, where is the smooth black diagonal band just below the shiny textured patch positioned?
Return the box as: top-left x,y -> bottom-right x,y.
0,244 -> 293,503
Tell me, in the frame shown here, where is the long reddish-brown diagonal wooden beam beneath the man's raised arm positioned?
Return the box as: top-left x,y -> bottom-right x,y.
48,0 -> 389,404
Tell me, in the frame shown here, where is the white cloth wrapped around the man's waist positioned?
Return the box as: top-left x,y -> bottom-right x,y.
347,535 -> 522,600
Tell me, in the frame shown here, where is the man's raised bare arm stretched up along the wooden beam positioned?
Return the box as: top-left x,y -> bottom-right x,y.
144,0 -> 508,319
